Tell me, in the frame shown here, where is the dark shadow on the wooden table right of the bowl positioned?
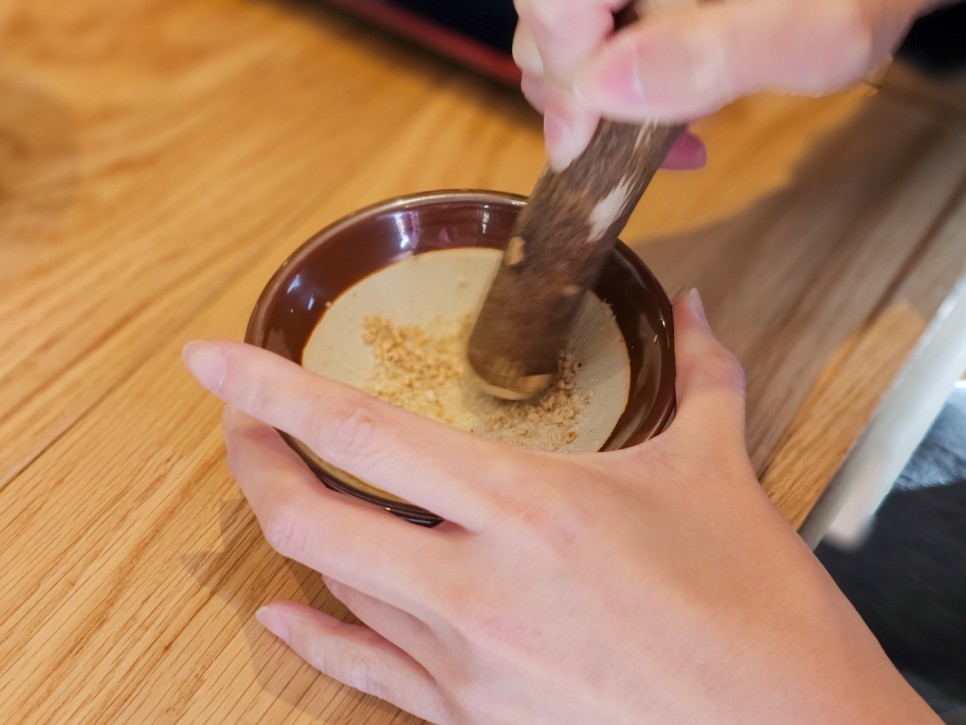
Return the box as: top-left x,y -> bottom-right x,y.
629,86 -> 964,475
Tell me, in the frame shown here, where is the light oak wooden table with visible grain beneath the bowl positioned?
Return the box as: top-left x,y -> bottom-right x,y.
0,0 -> 966,723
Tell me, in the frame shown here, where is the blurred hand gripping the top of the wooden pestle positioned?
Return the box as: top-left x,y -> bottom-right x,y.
513,0 -> 941,169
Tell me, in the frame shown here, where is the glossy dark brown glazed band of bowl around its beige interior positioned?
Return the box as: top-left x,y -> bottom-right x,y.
245,190 -> 674,525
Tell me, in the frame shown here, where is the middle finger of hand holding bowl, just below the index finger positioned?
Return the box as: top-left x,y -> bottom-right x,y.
223,408 -> 449,613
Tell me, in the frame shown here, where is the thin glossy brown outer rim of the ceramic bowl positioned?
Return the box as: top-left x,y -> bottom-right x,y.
245,188 -> 676,526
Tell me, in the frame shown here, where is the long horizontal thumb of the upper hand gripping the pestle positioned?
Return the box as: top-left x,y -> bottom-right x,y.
574,0 -> 912,121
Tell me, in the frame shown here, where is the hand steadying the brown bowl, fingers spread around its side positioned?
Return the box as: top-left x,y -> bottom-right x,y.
185,293 -> 931,724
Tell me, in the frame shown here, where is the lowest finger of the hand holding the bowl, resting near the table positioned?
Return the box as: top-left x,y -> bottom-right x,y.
255,602 -> 446,722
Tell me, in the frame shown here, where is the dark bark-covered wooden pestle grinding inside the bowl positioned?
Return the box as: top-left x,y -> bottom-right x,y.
468,2 -> 684,400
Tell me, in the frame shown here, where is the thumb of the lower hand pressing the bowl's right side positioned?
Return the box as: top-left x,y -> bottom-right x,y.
672,290 -> 745,448
